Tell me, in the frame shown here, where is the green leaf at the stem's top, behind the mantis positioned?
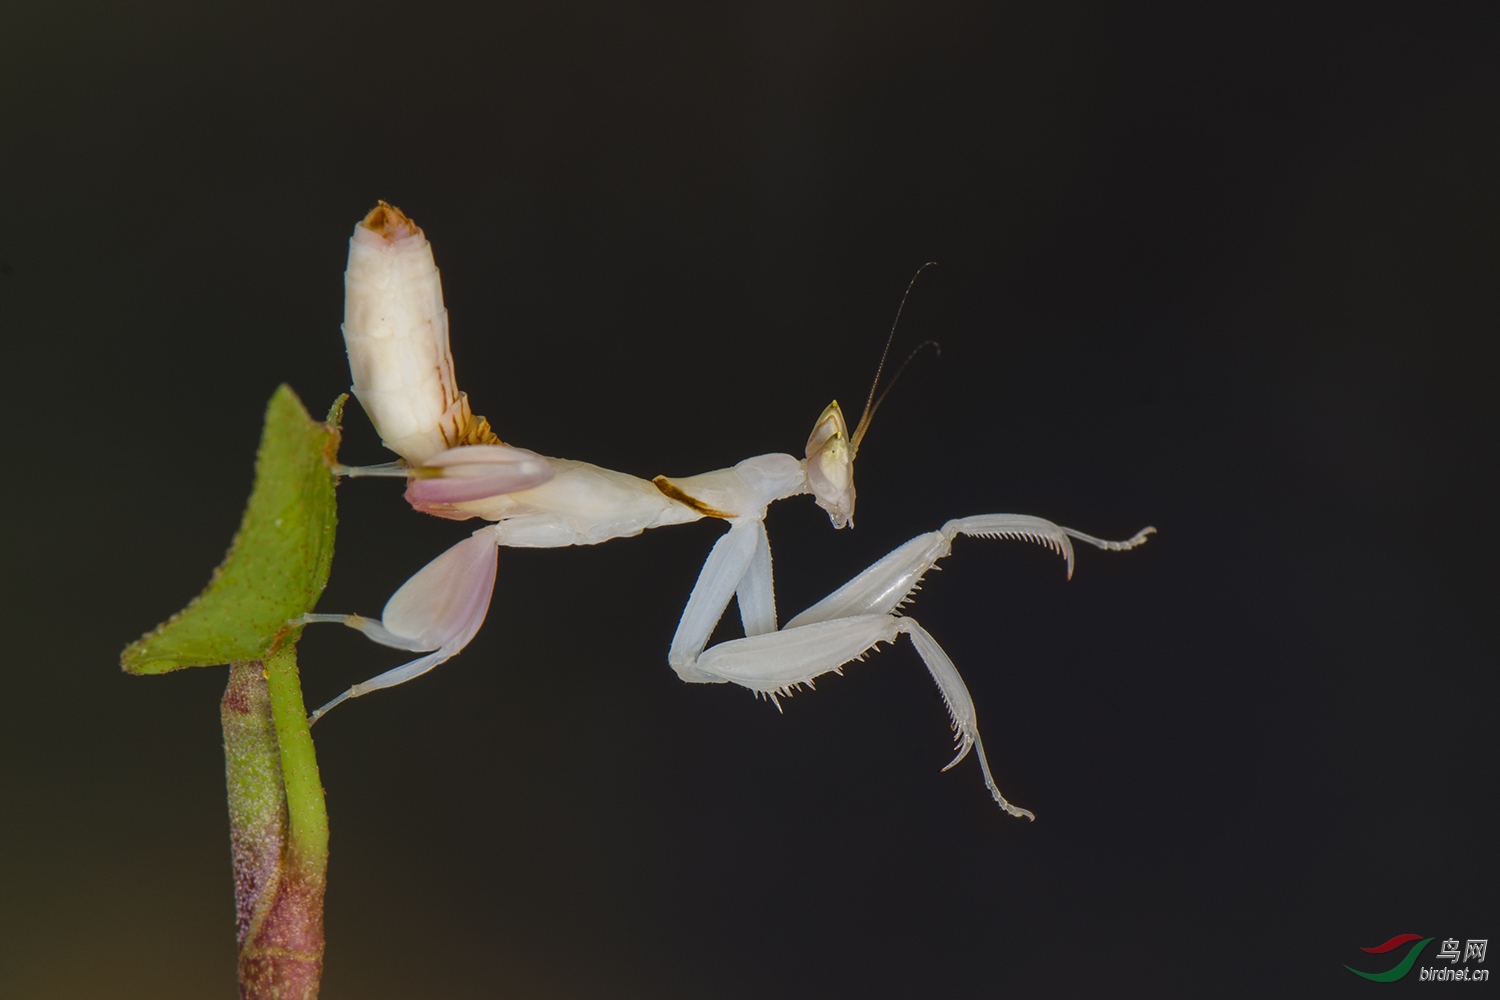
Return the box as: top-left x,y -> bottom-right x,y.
120,385 -> 347,673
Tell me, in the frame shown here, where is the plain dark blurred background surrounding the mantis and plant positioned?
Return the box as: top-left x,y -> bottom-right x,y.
0,0 -> 1500,1000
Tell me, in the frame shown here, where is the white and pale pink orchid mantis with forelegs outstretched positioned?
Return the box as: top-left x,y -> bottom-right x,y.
299,202 -> 1155,819
